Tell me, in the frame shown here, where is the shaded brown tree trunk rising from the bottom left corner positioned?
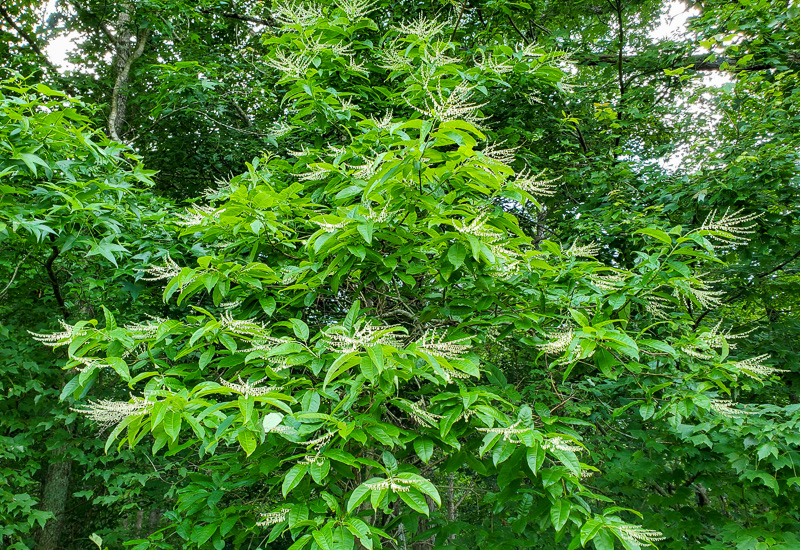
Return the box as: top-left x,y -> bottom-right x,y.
36,445 -> 72,550
